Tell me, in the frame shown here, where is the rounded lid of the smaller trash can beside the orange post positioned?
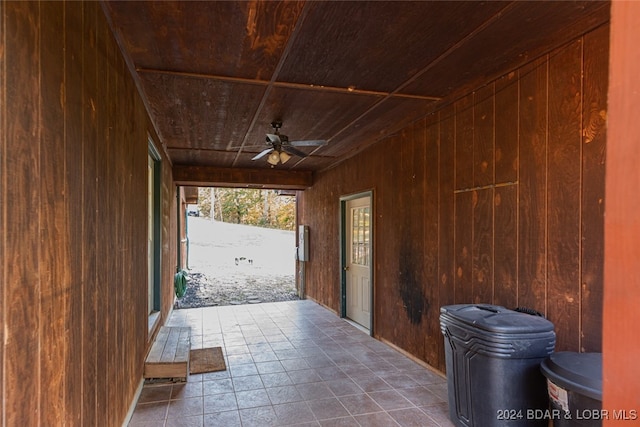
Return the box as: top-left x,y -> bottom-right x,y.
540,351 -> 602,401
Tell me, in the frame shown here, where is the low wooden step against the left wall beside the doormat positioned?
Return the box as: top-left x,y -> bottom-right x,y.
144,326 -> 191,380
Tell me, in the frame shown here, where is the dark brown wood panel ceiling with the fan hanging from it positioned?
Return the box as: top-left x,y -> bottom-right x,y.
104,1 -> 609,187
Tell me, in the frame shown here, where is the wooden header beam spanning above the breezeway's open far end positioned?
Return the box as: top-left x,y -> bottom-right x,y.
173,165 -> 313,190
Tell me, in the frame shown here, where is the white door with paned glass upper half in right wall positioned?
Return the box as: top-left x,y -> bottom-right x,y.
344,197 -> 371,329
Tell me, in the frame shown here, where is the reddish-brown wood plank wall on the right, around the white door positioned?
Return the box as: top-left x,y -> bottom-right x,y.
300,26 -> 609,370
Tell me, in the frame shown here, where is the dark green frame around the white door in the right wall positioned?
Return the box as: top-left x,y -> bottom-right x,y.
340,190 -> 376,336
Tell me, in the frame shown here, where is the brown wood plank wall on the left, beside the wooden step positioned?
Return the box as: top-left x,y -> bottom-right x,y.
0,1 -> 176,426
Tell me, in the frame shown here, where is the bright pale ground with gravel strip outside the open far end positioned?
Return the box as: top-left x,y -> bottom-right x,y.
176,217 -> 299,308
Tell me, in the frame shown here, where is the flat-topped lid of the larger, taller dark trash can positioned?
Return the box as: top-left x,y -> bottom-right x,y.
440,304 -> 554,334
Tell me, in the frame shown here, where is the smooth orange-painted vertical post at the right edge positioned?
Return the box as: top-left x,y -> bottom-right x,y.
603,1 -> 640,416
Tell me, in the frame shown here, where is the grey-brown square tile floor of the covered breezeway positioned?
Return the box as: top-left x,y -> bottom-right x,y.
129,300 -> 452,427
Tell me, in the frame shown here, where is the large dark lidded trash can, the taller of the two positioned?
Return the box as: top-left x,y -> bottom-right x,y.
440,304 -> 556,427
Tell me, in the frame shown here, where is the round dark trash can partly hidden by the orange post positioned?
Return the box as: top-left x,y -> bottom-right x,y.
540,351 -> 604,427
